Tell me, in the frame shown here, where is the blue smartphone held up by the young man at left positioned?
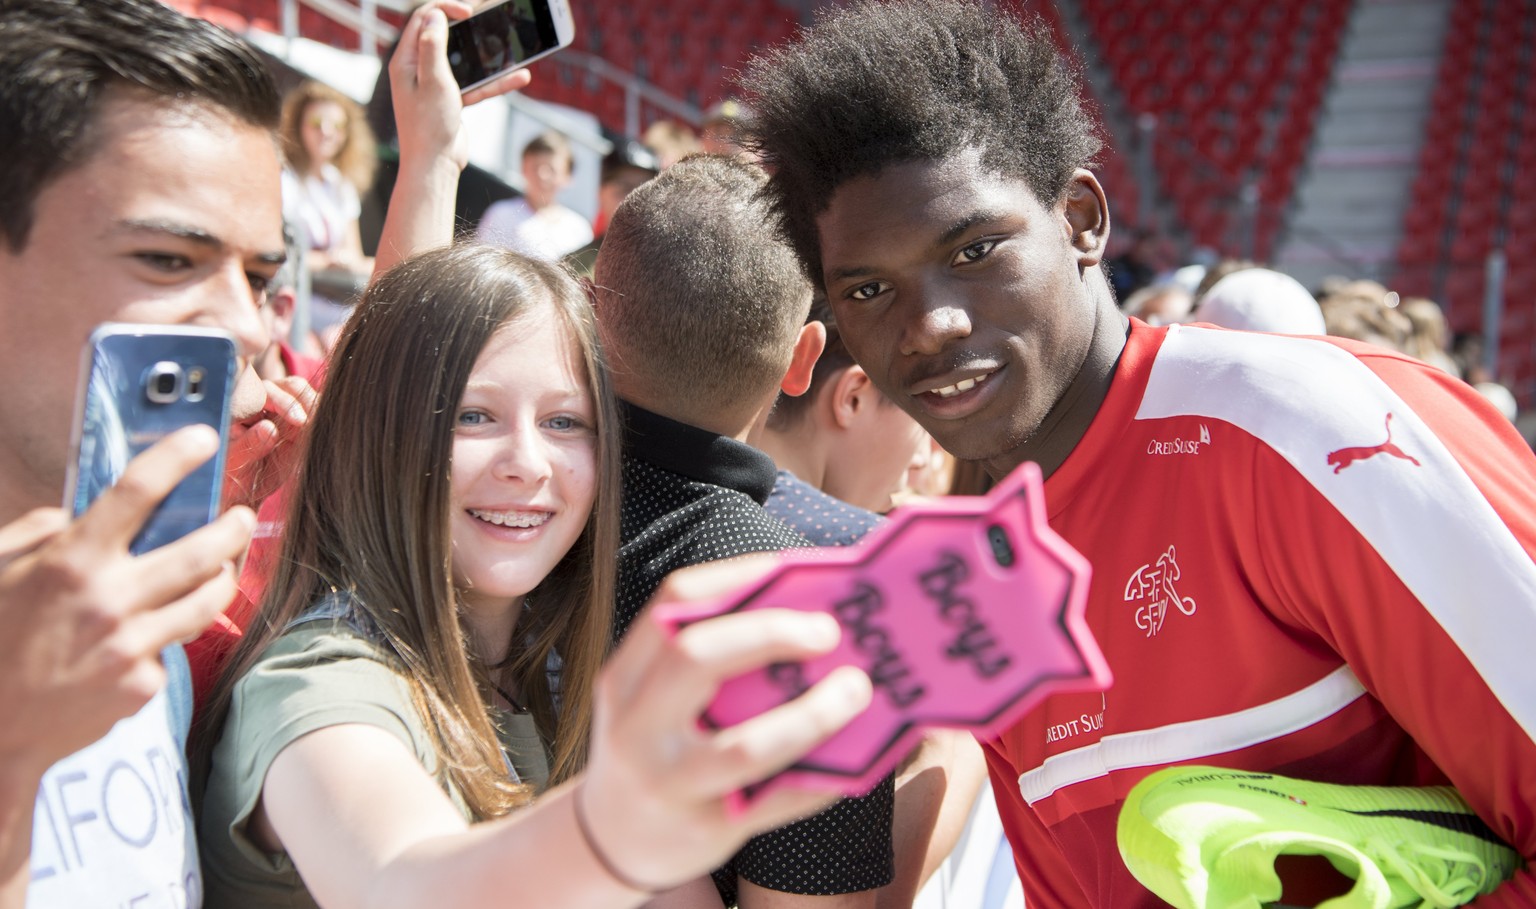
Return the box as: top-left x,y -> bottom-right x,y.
65,322 -> 237,554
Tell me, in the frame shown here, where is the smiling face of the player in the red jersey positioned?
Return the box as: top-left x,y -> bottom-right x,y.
816,155 -> 1095,465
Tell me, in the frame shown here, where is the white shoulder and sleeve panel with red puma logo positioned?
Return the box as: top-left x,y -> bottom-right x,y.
1137,327 -> 1536,740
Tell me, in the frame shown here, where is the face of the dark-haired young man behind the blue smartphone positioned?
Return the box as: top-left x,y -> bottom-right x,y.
0,92 -> 284,504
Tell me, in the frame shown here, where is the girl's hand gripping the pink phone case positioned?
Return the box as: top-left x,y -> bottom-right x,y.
577,556 -> 871,904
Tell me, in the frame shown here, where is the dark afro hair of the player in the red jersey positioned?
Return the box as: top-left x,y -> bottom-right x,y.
739,0 -> 1101,287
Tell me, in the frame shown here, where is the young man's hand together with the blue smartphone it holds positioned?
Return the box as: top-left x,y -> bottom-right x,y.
0,326 -> 255,764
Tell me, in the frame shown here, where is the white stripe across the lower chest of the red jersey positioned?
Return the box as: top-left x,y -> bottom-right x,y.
1018,666 -> 1366,805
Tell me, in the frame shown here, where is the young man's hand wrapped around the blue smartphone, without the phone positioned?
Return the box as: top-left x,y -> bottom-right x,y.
0,427 -> 255,778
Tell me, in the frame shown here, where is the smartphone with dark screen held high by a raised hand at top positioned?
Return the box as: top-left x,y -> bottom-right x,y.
449,0 -> 576,92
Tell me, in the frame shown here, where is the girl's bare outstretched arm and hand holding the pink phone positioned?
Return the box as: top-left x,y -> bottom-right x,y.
255,562 -> 869,909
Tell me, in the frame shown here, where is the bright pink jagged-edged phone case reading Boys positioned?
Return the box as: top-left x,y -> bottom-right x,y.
657,464 -> 1111,809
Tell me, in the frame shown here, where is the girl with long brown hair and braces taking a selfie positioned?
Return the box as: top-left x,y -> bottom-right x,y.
194,237 -> 868,909
